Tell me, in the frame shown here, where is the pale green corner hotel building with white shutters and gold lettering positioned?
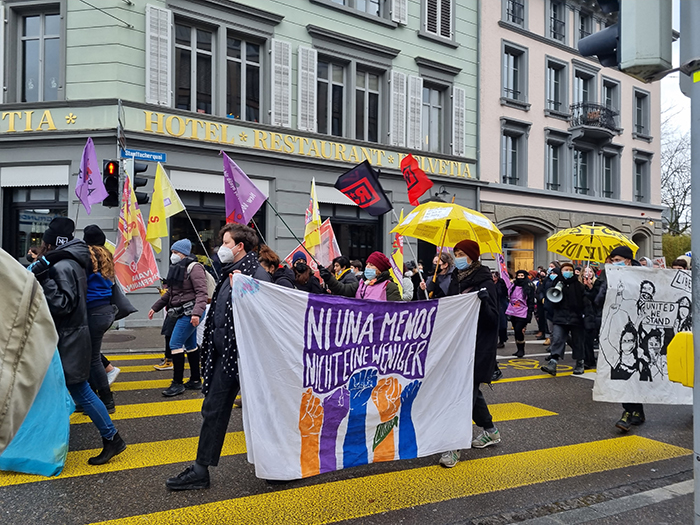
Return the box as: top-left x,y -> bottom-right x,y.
0,0 -> 484,324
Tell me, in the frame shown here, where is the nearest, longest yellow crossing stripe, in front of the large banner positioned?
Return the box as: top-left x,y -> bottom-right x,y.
89,436 -> 691,525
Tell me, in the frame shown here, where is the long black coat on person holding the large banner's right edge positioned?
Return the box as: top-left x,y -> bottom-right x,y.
448,265 -> 498,385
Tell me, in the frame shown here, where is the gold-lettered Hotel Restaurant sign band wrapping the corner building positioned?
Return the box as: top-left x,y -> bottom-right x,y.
0,106 -> 472,179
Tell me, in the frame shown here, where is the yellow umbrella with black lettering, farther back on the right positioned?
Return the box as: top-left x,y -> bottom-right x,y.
547,224 -> 639,263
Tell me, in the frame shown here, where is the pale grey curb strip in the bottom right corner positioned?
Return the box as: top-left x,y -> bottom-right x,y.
520,479 -> 695,525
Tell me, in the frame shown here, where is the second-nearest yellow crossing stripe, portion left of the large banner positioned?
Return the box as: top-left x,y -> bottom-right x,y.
0,432 -> 246,487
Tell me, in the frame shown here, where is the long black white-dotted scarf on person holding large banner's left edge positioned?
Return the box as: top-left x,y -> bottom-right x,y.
201,252 -> 260,396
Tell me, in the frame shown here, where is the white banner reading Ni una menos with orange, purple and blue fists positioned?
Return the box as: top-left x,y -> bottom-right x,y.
232,274 -> 480,480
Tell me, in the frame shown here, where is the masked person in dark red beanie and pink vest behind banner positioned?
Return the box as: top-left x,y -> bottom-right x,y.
318,252 -> 401,301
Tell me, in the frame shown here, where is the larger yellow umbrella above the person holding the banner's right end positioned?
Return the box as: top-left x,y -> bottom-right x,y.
391,202 -> 503,255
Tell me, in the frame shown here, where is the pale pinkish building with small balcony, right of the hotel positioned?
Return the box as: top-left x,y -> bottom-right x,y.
478,0 -> 662,271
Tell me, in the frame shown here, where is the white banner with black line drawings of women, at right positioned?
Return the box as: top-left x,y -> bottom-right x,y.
593,264 -> 693,405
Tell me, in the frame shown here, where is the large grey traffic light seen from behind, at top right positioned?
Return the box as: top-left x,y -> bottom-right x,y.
578,0 -> 672,82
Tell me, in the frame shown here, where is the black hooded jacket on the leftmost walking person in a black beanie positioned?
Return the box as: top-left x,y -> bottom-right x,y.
38,239 -> 92,385
